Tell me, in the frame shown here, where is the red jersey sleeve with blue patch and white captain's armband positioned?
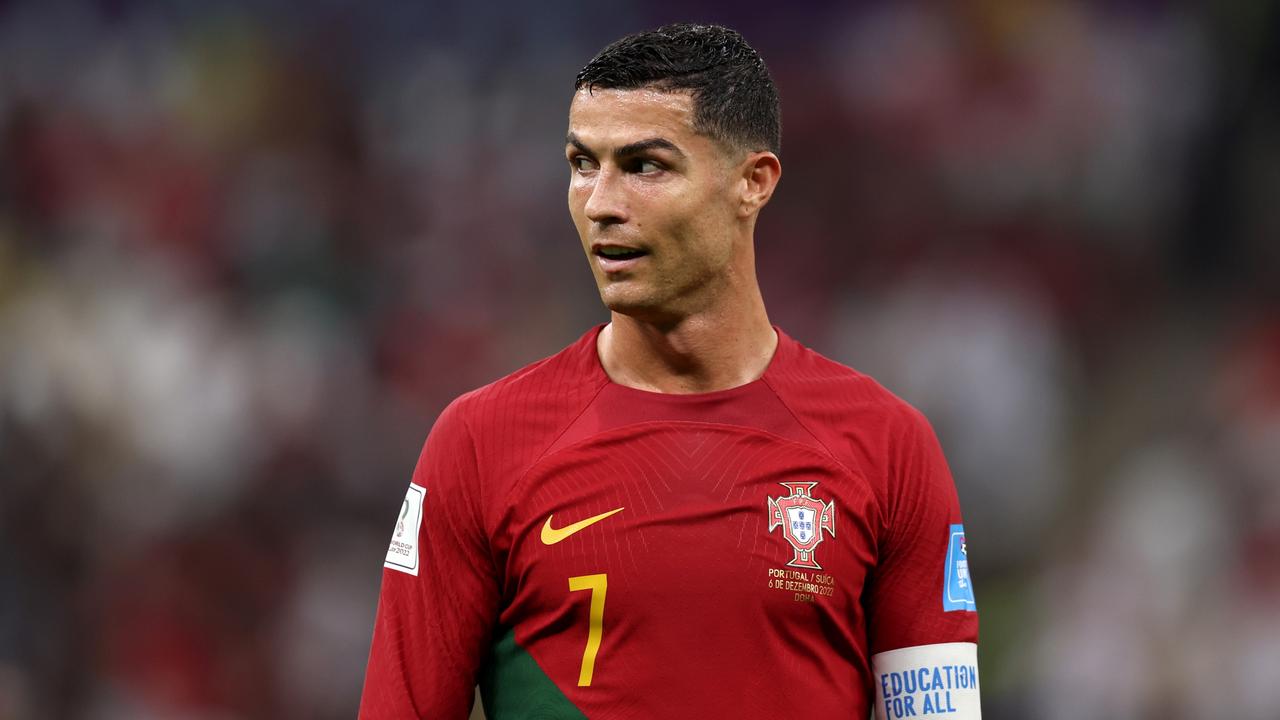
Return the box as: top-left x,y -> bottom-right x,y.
865,410 -> 980,720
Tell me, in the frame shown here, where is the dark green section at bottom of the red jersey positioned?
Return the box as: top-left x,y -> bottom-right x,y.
480,630 -> 586,720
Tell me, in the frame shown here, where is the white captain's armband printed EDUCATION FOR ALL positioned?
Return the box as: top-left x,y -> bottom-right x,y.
872,643 -> 982,720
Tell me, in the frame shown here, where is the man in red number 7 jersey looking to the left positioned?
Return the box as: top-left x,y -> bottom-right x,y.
361,24 -> 979,720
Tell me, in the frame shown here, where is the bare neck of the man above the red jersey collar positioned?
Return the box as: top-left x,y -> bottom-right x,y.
596,287 -> 778,393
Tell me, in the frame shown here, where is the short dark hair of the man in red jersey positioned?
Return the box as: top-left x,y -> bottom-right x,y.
573,23 -> 782,152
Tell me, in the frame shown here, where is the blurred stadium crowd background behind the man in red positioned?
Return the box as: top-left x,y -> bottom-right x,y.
0,0 -> 1280,720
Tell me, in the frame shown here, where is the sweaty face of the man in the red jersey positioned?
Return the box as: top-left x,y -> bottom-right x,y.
564,90 -> 750,322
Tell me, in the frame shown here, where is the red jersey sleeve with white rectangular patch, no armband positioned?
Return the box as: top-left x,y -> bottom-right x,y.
360,402 -> 500,720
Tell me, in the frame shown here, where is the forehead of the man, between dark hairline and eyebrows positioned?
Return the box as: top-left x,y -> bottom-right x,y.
568,88 -> 707,145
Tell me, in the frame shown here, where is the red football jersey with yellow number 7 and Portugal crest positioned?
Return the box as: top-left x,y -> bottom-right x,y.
361,328 -> 978,720
